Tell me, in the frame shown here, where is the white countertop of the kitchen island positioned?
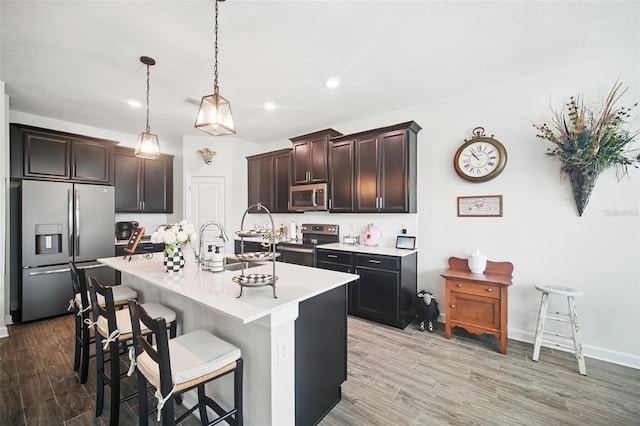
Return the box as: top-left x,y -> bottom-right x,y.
98,255 -> 358,324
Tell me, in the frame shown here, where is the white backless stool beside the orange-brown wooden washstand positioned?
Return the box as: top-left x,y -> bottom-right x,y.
533,285 -> 587,376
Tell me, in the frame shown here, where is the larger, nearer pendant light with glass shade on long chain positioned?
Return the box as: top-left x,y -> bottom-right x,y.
195,0 -> 236,136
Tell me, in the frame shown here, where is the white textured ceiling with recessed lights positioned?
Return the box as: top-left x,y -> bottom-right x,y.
0,0 -> 640,143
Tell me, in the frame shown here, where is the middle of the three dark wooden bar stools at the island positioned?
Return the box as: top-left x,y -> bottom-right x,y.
89,276 -> 176,426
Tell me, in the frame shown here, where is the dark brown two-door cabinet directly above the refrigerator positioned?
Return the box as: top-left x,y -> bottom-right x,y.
10,124 -> 118,185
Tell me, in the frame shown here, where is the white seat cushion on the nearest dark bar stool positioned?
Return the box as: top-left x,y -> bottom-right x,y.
136,330 -> 241,389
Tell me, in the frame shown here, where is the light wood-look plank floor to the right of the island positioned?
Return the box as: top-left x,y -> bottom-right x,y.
320,317 -> 640,426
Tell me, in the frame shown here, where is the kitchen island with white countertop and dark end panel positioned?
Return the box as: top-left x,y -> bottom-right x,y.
98,255 -> 358,425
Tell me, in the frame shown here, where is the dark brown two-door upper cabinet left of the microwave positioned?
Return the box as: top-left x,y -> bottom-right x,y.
247,148 -> 292,213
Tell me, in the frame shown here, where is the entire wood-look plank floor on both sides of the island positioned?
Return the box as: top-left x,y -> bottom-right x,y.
0,315 -> 640,426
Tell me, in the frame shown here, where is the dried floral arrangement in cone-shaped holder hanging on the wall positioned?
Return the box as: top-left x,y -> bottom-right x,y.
533,81 -> 640,216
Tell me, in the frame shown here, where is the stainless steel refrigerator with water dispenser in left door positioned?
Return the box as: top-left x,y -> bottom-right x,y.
19,180 -> 115,321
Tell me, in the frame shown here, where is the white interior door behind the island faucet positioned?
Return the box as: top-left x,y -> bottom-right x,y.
186,176 -> 226,253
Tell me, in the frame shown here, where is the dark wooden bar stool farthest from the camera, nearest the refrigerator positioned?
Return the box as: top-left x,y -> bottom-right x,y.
69,262 -> 138,383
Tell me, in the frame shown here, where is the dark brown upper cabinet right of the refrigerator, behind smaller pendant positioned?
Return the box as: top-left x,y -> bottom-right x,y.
115,147 -> 173,213
